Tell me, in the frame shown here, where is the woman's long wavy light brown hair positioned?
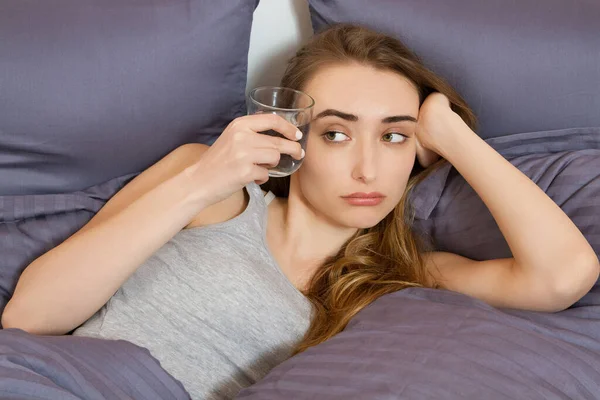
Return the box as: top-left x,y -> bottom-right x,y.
263,24 -> 475,353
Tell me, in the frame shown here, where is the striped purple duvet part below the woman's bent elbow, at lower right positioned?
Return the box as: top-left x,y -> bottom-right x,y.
237,288 -> 600,400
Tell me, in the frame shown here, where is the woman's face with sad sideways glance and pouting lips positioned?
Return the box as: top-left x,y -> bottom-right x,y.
292,64 -> 419,228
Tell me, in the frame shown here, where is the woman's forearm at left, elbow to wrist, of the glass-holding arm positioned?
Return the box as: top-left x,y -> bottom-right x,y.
2,174 -> 204,334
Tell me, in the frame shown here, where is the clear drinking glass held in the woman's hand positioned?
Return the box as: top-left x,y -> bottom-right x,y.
247,86 -> 315,177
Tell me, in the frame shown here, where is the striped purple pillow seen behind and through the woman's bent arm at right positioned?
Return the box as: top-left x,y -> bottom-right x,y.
411,128 -> 600,302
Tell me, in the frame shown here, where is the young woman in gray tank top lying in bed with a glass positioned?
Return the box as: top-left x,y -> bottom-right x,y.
2,25 -> 599,398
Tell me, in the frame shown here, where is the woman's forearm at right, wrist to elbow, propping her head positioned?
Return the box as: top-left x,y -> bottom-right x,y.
441,121 -> 598,295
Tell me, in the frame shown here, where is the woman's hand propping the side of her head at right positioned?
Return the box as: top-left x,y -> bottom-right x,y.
415,92 -> 464,168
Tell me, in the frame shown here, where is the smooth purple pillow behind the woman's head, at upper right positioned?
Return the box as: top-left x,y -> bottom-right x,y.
310,0 -> 600,138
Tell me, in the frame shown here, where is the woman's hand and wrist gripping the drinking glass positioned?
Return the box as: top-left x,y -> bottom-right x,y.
185,114 -> 304,207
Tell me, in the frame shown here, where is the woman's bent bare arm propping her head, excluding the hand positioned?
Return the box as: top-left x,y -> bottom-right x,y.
418,94 -> 600,311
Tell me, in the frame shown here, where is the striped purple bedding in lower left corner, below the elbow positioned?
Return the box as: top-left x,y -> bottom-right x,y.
0,329 -> 190,400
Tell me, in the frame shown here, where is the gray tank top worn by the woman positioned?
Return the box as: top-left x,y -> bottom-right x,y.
74,184 -> 311,399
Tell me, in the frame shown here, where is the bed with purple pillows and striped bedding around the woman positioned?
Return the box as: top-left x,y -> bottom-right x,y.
0,0 -> 600,400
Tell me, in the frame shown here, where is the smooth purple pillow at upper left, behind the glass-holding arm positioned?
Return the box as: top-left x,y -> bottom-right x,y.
0,0 -> 258,196
